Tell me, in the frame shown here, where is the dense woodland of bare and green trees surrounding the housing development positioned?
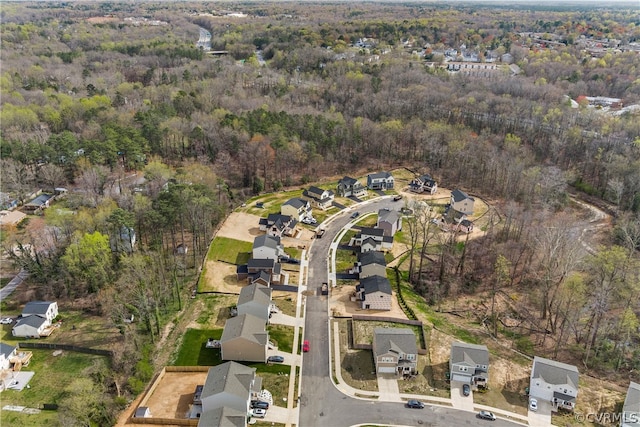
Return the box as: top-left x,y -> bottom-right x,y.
0,2 -> 640,424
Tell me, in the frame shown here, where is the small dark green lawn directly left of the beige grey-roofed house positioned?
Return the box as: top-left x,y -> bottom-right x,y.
173,329 -> 222,366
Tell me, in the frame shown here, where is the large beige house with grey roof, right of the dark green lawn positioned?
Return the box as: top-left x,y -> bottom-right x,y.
220,314 -> 269,362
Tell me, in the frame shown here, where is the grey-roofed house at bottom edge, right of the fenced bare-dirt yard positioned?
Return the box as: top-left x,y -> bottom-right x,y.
198,362 -> 262,427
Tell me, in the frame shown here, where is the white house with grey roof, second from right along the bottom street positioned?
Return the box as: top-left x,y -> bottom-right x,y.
529,356 -> 578,411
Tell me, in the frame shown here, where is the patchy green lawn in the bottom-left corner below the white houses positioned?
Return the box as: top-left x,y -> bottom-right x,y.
0,350 -> 107,427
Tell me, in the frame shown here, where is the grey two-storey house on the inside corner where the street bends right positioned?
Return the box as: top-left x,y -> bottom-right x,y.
372,328 -> 418,375
